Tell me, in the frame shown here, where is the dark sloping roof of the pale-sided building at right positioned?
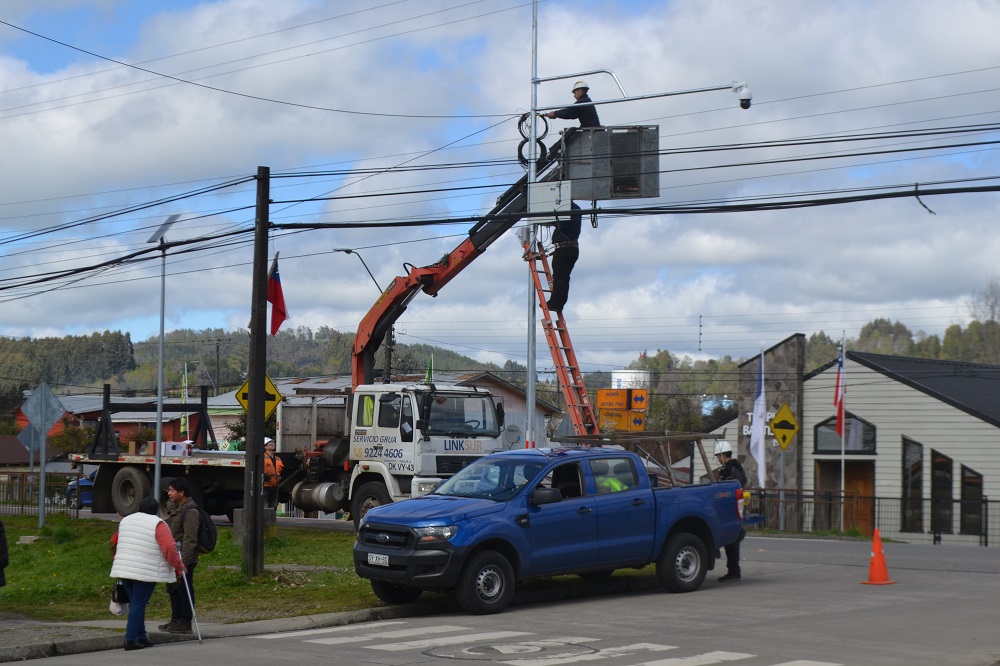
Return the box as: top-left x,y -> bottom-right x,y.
848,351 -> 1000,426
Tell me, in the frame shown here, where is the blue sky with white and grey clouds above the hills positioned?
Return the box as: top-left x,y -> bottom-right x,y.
0,0 -> 1000,372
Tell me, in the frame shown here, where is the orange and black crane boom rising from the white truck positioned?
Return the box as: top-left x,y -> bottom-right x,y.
351,148 -> 562,387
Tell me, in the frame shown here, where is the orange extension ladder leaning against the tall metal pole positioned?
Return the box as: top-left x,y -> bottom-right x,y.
524,241 -> 599,435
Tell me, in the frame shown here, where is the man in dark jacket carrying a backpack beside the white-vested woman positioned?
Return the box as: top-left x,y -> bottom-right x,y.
159,477 -> 201,634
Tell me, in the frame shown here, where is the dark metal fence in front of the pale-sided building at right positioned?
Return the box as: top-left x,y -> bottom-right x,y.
743,489 -> 1000,546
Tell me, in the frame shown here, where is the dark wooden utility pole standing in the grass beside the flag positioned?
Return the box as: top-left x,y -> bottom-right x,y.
243,166 -> 271,578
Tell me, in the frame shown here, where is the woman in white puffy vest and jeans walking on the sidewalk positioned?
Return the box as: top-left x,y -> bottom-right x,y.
111,497 -> 184,650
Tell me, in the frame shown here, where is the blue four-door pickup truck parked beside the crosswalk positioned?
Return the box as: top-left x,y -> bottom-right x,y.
354,448 -> 742,614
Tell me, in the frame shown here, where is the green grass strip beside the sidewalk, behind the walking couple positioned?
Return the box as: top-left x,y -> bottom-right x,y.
0,516 -> 382,623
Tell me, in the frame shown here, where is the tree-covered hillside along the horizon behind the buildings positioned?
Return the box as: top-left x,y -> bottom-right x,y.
0,280 -> 1000,434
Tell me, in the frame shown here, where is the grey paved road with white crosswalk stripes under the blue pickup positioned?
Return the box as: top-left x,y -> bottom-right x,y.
13,537 -> 1000,666
